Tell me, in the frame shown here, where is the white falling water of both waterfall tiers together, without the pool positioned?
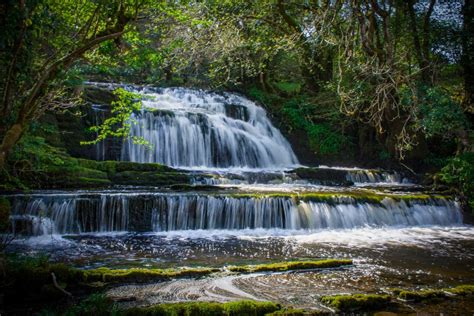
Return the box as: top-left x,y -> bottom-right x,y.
6,86 -> 462,235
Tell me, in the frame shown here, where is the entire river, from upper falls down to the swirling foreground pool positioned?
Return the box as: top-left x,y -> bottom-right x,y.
7,84 -> 474,308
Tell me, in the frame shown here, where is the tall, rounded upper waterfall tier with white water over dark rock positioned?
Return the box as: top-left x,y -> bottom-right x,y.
118,88 -> 298,168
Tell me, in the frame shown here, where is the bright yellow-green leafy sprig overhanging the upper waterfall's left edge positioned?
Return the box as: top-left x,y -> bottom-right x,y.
81,88 -> 151,147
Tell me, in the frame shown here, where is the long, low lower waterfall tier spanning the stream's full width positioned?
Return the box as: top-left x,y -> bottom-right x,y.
10,193 -> 462,235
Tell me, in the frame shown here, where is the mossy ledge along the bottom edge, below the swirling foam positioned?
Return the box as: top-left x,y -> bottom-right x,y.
123,301 -> 281,316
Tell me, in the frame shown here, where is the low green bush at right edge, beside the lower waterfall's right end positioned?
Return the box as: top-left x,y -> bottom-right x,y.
439,153 -> 474,210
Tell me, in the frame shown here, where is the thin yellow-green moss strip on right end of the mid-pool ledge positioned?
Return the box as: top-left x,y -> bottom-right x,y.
228,259 -> 352,273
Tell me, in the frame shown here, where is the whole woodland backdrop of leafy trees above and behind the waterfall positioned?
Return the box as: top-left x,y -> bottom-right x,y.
0,0 -> 472,172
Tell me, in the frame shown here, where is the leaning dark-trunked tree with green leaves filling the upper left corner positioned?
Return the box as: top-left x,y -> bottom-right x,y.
0,0 -> 146,169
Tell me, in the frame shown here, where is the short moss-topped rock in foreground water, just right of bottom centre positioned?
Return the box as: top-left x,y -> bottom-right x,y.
321,294 -> 390,311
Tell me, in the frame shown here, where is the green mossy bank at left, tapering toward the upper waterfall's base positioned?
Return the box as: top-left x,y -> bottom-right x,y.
6,135 -> 189,189
